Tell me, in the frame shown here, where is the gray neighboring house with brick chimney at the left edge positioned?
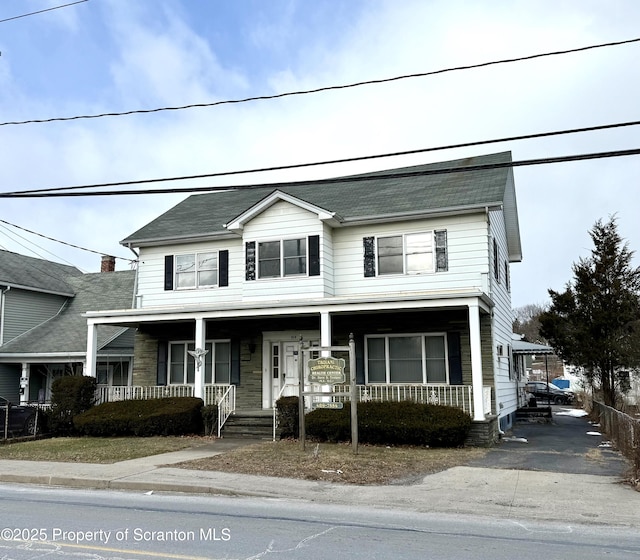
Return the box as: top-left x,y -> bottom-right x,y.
0,251 -> 135,403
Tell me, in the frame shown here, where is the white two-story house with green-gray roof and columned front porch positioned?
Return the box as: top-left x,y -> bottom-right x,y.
86,152 -> 521,436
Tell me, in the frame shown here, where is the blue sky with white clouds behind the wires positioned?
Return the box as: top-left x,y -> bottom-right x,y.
0,0 -> 640,308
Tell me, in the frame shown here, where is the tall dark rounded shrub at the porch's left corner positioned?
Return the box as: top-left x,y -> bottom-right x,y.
46,375 -> 96,436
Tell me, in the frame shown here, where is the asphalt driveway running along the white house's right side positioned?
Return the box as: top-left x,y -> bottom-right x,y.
469,405 -> 630,477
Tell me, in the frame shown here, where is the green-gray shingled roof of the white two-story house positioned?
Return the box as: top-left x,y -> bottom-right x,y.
121,152 -> 511,246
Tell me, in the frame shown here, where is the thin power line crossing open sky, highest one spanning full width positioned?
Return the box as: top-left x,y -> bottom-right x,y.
0,37 -> 640,126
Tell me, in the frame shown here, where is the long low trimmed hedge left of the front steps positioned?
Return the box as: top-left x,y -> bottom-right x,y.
73,397 -> 204,437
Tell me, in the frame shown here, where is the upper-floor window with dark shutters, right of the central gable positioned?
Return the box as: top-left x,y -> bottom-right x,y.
364,230 -> 449,276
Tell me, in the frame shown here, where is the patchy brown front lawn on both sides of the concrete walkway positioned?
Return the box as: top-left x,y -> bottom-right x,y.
0,436 -> 487,484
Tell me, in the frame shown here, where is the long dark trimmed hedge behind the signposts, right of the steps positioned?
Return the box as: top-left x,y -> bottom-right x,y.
305,401 -> 471,447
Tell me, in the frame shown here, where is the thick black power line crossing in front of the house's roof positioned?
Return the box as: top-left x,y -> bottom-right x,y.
0,148 -> 640,198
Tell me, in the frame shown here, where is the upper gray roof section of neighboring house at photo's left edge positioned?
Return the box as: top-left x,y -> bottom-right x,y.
0,250 -> 82,296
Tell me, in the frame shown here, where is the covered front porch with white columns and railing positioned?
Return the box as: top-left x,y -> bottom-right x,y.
85,297 -> 496,434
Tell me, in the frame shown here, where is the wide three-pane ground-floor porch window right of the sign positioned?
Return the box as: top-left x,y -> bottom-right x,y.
365,334 -> 448,383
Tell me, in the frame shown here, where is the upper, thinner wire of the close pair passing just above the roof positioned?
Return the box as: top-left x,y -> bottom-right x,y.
8,121 -> 640,195
